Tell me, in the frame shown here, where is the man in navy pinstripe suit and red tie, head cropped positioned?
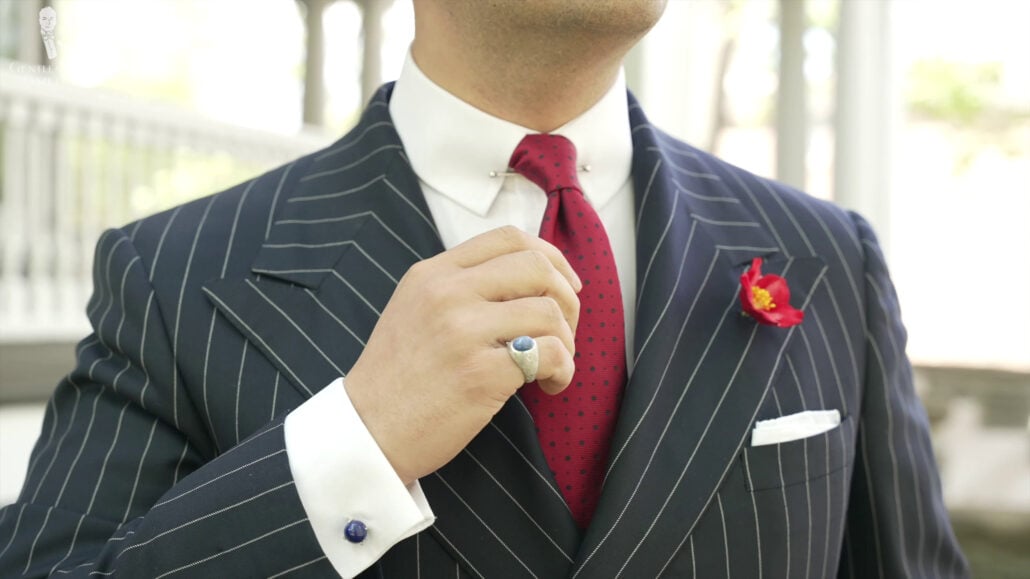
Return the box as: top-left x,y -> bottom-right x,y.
0,0 -> 967,578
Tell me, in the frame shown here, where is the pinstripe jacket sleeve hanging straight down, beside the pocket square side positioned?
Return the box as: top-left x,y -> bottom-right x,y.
838,214 -> 969,578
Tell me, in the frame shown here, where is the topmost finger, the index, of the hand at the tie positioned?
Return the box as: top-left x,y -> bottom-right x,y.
449,226 -> 583,294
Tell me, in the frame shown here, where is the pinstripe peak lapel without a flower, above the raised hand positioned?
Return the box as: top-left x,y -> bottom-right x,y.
204,88 -> 443,397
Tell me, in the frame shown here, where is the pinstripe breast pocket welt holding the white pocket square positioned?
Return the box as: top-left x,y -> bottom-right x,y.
742,416 -> 855,492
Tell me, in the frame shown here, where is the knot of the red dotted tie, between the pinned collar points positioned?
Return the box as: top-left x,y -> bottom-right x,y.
508,134 -> 583,195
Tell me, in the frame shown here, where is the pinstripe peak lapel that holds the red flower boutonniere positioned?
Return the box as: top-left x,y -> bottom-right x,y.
573,101 -> 824,577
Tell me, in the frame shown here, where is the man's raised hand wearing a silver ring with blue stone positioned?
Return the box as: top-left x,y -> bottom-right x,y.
345,227 -> 582,484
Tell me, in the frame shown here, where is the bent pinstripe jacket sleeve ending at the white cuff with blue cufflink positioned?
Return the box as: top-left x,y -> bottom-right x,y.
0,230 -> 333,578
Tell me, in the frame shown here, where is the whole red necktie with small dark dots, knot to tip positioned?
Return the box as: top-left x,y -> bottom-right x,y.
510,134 -> 626,529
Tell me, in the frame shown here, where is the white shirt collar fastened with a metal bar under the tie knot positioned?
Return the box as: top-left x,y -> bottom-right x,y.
389,52 -> 632,216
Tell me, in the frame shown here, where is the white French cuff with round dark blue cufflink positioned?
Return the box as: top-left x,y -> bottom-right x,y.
284,378 -> 436,577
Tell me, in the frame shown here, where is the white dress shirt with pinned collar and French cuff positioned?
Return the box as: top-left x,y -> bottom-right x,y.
285,54 -> 637,577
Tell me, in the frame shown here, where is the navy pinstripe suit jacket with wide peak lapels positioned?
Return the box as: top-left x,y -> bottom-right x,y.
0,86 -> 967,579
